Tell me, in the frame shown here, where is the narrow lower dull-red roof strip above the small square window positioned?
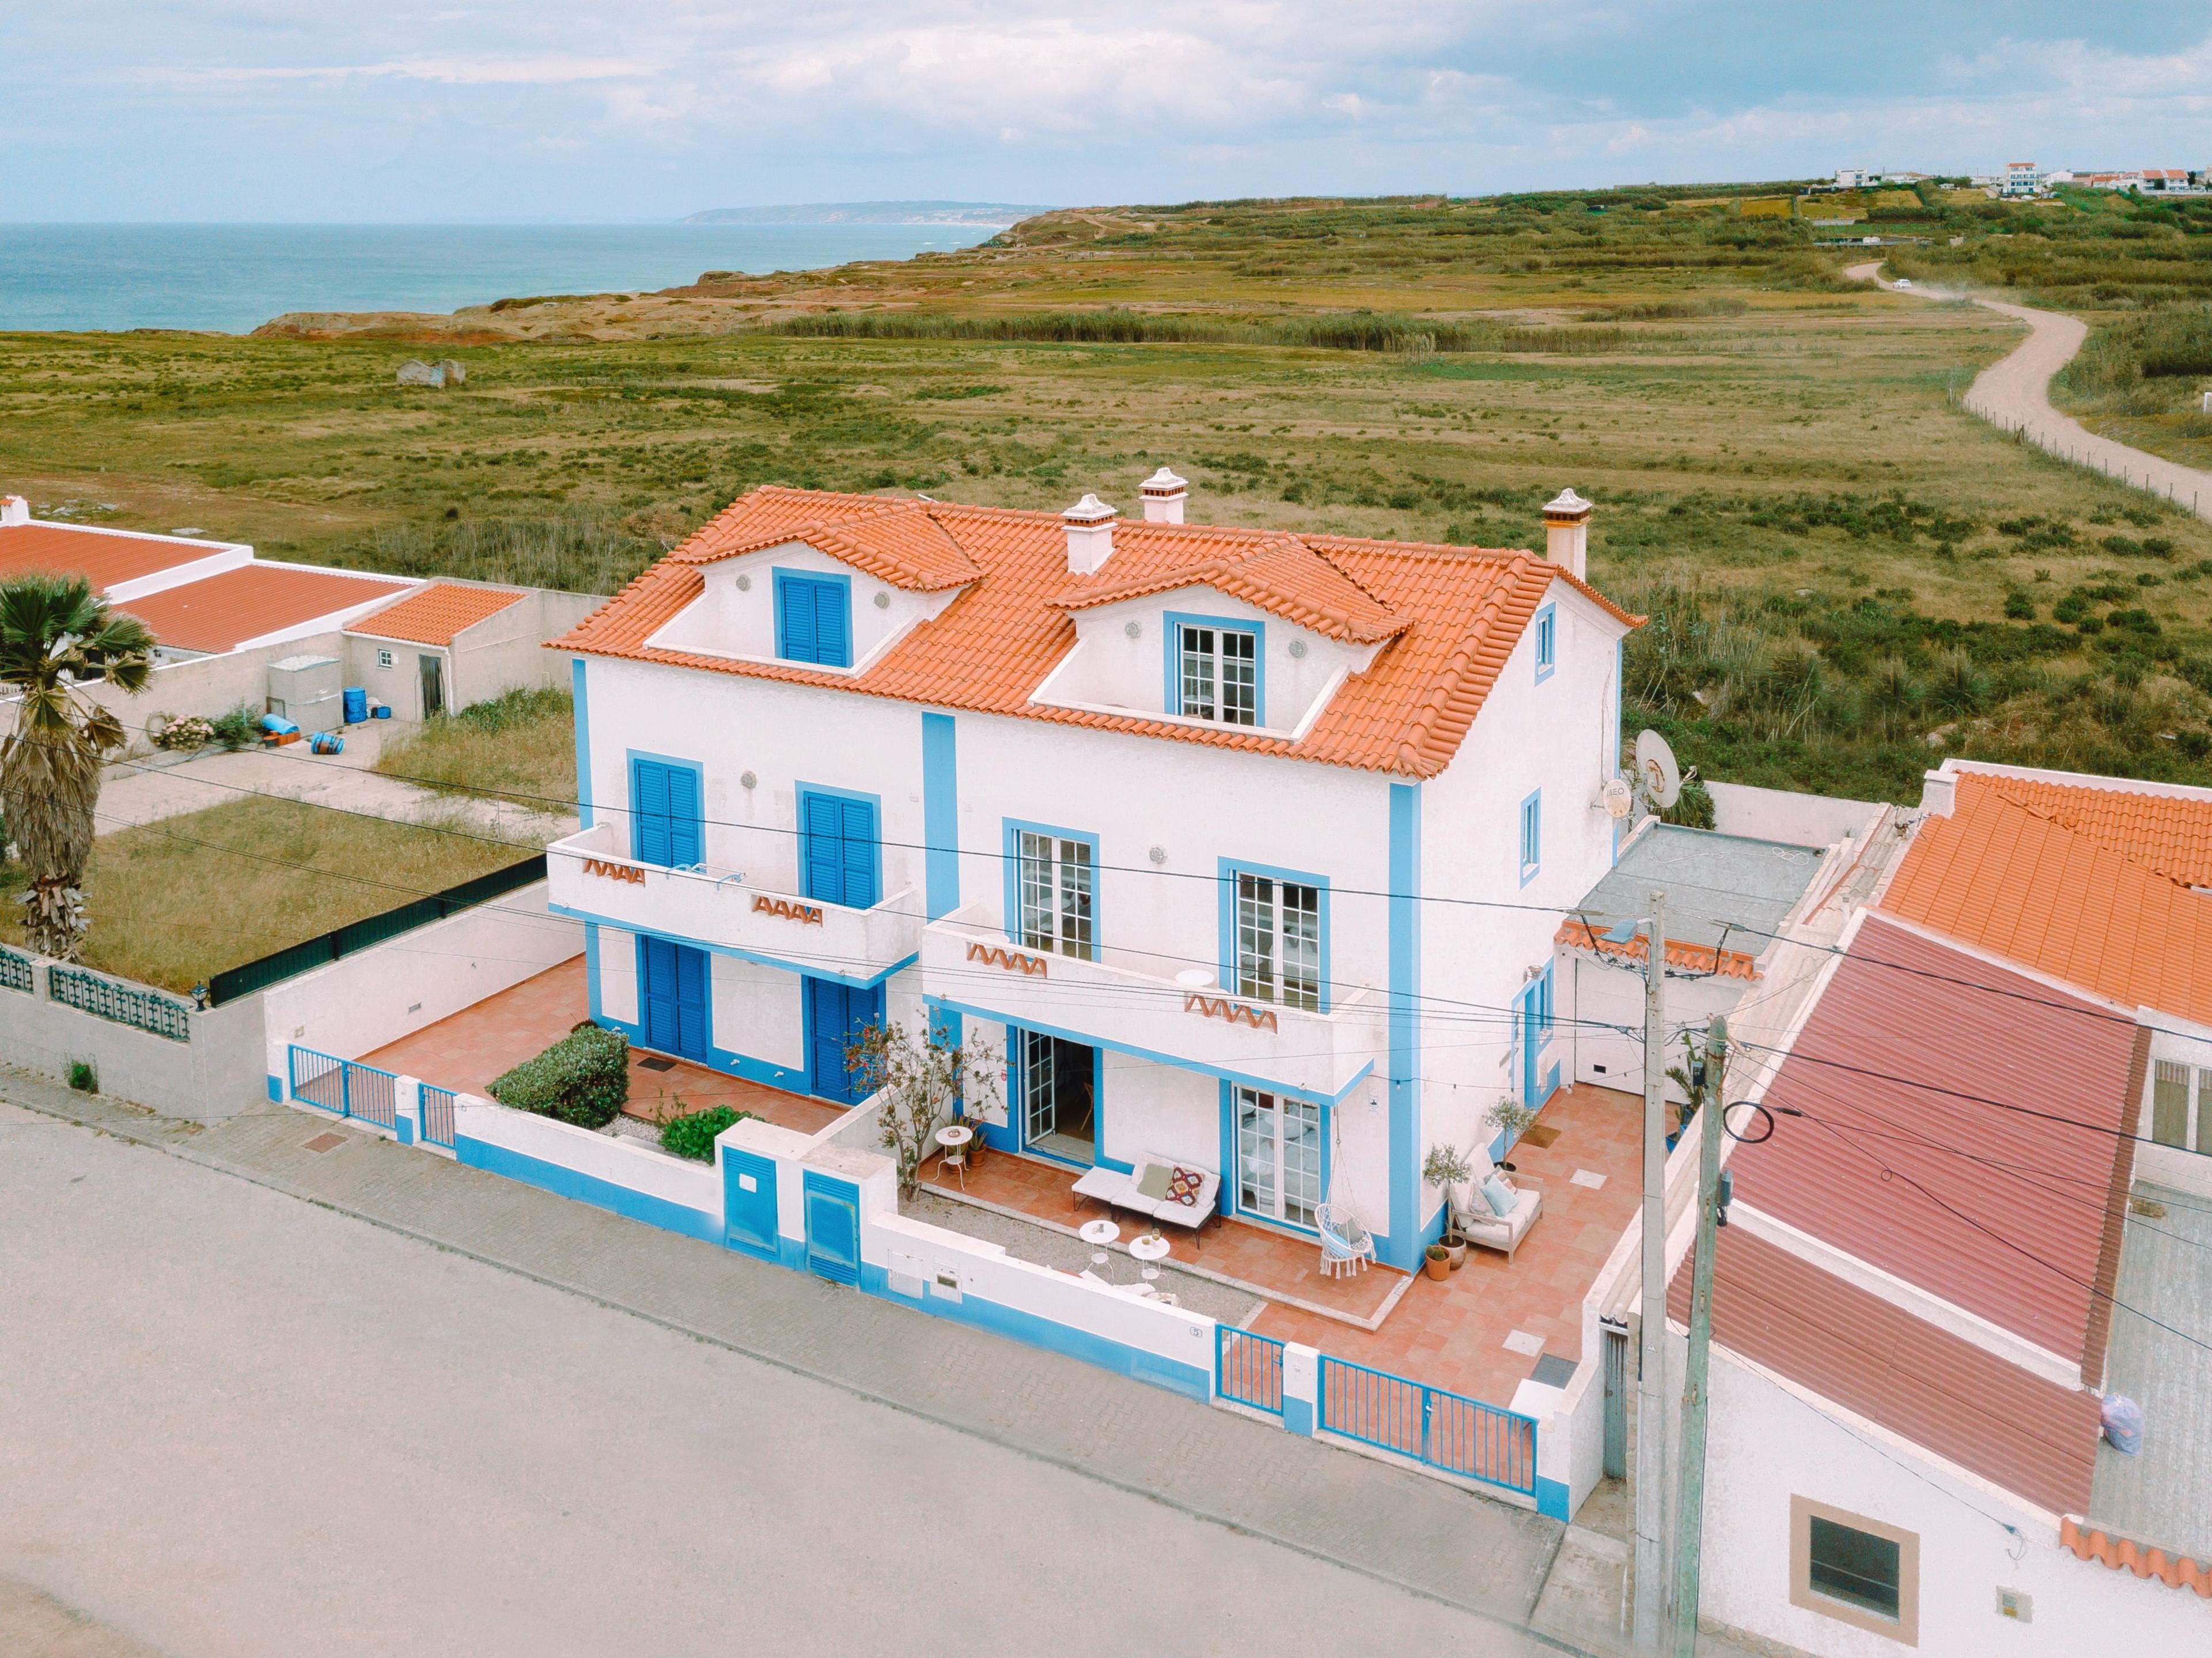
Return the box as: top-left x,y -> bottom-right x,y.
1668,1222 -> 2099,1514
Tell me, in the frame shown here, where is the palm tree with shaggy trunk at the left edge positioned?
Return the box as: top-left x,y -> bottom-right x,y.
0,576 -> 155,961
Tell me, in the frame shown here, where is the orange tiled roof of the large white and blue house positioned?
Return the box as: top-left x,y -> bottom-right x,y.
553,484 -> 1641,777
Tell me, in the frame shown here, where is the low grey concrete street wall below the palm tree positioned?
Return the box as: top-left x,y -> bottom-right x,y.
0,956 -> 266,1122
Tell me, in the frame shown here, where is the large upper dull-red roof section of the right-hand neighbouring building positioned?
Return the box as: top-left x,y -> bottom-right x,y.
1730,914 -> 2148,1386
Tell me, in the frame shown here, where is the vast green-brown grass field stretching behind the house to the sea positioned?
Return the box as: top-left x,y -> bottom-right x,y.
0,186 -> 2212,799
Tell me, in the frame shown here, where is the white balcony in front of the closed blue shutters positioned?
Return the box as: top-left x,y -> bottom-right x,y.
546,823 -> 922,983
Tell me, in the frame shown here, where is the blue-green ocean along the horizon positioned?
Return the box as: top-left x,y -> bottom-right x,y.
0,224 -> 1013,334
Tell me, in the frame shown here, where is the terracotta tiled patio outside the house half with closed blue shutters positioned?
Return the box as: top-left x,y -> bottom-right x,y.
361,956 -> 845,1133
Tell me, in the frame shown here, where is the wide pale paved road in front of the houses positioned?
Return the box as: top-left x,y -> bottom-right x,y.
0,1097 -> 1601,1658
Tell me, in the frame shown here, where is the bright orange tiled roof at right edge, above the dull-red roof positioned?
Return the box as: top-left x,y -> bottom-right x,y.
1883,773 -> 2212,1023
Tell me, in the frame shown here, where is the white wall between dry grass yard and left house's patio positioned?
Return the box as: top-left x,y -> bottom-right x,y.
256,881 -> 584,1082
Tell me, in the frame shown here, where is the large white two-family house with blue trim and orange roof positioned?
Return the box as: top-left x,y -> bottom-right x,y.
551,470 -> 1635,1266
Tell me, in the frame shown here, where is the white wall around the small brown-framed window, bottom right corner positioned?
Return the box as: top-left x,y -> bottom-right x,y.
1677,1342 -> 2212,1658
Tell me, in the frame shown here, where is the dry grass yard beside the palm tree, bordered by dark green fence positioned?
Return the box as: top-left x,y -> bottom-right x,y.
0,799 -> 535,991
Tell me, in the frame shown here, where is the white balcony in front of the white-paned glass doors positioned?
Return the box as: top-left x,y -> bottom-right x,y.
922,910 -> 1385,1100
